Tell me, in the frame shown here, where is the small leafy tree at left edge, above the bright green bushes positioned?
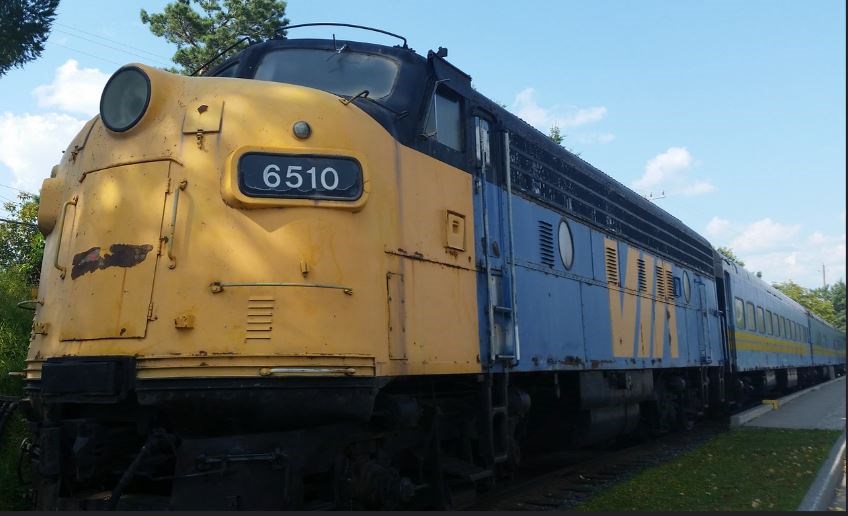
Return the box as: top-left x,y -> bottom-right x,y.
0,192 -> 44,285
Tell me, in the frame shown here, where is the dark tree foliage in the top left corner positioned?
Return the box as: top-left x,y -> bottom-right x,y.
0,0 -> 59,76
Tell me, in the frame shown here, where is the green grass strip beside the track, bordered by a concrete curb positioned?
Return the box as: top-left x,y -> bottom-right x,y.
574,428 -> 840,511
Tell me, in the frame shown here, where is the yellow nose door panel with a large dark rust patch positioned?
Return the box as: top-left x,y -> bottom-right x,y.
59,161 -> 169,340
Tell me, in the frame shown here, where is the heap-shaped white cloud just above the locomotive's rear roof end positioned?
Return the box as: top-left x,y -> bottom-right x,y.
632,147 -> 716,197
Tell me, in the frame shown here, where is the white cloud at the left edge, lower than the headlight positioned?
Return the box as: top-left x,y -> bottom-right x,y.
0,113 -> 85,192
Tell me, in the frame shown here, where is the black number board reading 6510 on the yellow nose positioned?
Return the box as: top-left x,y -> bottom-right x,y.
238,152 -> 362,201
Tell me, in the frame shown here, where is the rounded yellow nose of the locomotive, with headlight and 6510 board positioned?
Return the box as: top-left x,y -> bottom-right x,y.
28,64 -> 479,379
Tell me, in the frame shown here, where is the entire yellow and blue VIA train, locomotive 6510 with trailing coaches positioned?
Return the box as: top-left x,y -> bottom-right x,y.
16,27 -> 845,509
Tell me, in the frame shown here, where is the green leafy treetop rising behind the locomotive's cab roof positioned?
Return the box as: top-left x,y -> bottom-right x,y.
141,0 -> 289,75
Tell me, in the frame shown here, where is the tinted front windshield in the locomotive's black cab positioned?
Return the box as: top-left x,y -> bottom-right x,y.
254,47 -> 398,99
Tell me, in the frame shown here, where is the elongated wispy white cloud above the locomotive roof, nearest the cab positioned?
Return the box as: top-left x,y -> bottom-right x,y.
511,88 -> 615,134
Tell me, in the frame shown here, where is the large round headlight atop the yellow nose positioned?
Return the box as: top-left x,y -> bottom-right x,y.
100,66 -> 150,133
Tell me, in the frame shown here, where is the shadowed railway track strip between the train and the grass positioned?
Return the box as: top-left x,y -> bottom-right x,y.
470,421 -> 728,511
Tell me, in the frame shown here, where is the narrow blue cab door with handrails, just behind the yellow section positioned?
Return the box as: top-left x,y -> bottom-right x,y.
474,116 -> 520,363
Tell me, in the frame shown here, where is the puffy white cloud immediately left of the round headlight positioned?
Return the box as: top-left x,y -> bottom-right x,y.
33,59 -> 109,116
